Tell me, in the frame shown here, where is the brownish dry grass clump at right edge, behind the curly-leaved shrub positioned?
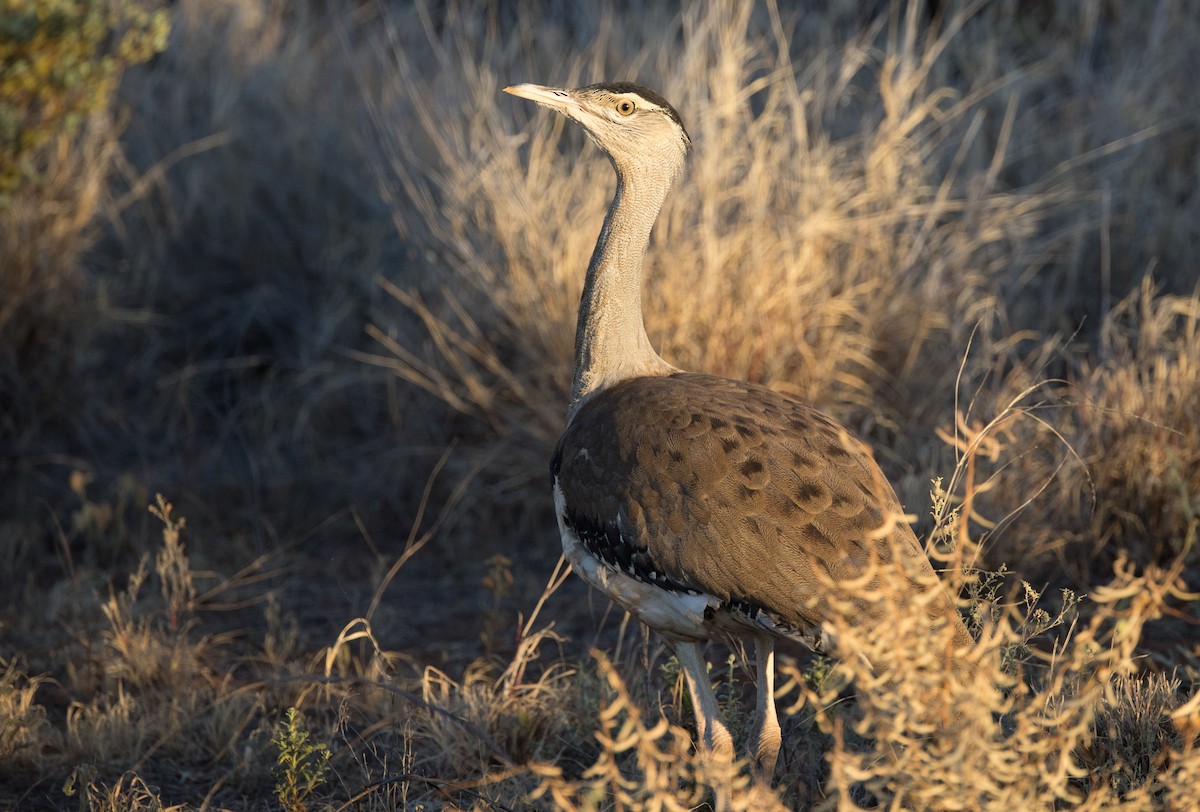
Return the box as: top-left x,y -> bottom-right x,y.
969,278 -> 1200,575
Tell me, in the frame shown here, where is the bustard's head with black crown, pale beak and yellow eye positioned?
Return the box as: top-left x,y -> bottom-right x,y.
504,82 -> 691,180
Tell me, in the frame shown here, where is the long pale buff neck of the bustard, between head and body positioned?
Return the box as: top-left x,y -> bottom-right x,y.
570,172 -> 674,415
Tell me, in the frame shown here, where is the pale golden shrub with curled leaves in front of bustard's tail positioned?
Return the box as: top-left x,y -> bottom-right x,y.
793,522 -> 1200,810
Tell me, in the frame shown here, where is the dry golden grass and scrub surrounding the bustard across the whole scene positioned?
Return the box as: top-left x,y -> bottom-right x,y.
0,0 -> 1200,810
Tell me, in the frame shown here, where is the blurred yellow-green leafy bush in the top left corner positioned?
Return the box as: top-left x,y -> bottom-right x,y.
0,0 -> 170,209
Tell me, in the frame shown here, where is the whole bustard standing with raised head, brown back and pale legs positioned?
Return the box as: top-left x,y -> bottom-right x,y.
505,82 -> 971,780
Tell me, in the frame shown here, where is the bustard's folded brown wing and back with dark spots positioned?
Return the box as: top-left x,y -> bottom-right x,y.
553,373 -> 949,628
